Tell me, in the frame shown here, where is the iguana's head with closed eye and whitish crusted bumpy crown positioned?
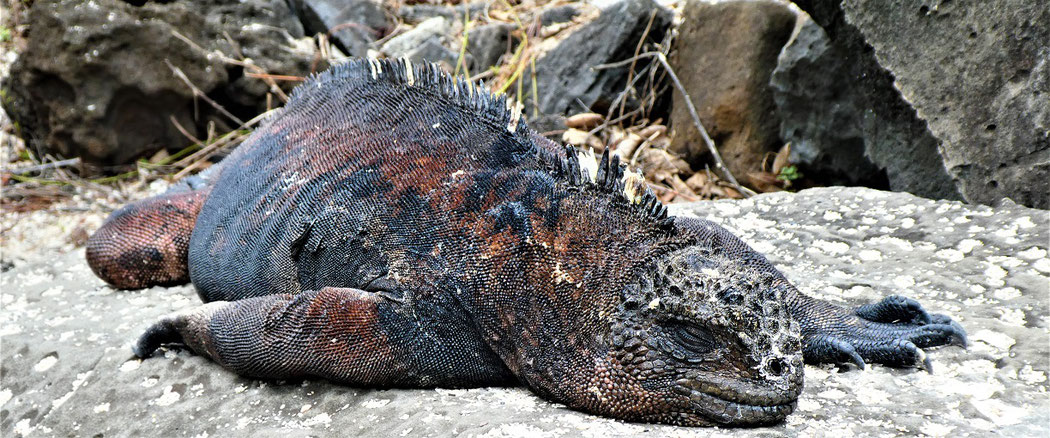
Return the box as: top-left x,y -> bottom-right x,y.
593,218 -> 802,425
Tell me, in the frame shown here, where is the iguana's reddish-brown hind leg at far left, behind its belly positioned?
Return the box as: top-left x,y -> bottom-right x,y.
86,186 -> 211,289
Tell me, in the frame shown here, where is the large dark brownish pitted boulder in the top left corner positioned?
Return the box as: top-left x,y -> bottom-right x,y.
2,0 -> 323,166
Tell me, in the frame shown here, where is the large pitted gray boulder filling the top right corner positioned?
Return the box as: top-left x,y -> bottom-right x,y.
796,0 -> 1050,208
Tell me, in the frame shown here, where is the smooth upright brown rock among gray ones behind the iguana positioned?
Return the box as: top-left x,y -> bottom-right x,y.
670,1 -> 796,181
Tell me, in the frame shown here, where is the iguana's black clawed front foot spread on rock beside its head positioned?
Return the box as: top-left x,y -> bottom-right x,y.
789,292 -> 966,372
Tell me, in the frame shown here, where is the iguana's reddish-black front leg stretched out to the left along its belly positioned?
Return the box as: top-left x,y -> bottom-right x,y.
134,288 -> 513,387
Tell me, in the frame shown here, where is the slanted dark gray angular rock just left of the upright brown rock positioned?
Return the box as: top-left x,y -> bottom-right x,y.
525,0 -> 671,114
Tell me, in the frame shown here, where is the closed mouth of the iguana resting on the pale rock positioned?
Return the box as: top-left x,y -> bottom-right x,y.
675,379 -> 802,425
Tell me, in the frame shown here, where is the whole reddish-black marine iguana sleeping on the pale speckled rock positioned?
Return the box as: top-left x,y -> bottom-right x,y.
87,60 -> 966,425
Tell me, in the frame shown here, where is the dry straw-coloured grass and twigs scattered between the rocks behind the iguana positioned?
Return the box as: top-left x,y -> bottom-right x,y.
0,0 -> 790,216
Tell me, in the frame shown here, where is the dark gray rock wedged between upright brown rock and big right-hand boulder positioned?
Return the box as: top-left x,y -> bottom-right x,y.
770,13 -> 889,188
